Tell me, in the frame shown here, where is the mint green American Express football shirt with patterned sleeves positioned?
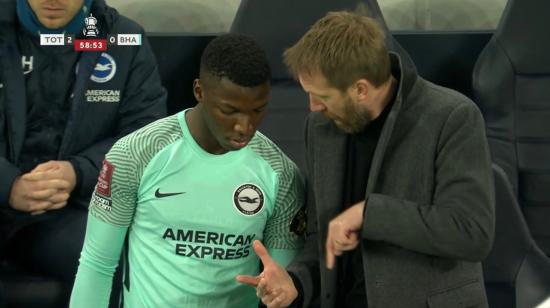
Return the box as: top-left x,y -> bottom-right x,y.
71,111 -> 304,308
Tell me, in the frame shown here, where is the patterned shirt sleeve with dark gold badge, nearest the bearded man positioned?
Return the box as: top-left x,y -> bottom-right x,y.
264,161 -> 305,266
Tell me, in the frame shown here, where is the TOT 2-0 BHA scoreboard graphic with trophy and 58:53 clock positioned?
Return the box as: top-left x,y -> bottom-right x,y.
40,14 -> 141,51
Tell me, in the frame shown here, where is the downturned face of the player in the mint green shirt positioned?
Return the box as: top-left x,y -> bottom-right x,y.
194,78 -> 270,154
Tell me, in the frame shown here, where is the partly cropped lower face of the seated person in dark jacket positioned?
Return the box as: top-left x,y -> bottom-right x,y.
27,0 -> 84,29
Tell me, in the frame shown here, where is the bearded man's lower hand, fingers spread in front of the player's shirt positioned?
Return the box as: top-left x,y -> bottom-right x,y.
236,241 -> 298,308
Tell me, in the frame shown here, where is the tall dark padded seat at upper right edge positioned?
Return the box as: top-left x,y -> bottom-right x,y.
472,0 -> 550,255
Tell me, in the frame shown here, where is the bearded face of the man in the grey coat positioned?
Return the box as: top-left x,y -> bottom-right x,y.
299,74 -> 372,134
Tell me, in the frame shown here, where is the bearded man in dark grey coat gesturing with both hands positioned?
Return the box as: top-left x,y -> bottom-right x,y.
239,12 -> 495,308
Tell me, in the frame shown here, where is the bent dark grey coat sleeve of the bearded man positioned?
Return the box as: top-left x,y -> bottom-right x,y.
362,103 -> 495,262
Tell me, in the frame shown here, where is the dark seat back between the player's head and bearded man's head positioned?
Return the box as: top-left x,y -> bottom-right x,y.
231,0 -> 412,171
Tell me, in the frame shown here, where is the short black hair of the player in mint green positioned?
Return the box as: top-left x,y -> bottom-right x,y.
200,33 -> 271,87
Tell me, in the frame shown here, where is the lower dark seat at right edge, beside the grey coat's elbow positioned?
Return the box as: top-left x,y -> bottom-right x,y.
483,164 -> 550,308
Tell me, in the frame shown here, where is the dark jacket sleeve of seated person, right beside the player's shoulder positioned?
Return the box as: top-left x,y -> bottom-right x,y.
69,34 -> 166,206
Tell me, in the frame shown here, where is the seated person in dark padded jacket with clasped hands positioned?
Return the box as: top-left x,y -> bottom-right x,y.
0,0 -> 166,301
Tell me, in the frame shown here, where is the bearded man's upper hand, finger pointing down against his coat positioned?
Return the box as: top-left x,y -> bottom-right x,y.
325,201 -> 365,269
